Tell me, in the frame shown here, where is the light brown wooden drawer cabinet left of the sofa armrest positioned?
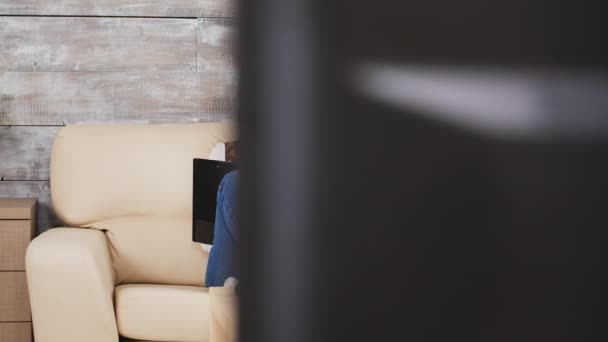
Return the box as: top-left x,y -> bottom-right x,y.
0,198 -> 36,342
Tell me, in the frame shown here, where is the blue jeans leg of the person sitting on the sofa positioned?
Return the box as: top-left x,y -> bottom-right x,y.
205,171 -> 239,287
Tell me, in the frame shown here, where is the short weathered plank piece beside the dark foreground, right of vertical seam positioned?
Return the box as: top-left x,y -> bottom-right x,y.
197,18 -> 237,71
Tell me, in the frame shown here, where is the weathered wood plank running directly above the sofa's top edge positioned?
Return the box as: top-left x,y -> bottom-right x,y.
0,72 -> 236,125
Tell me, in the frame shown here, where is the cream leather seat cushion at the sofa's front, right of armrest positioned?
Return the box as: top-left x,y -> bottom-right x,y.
115,284 -> 210,342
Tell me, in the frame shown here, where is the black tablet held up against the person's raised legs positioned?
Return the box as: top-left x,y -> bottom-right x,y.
192,159 -> 236,245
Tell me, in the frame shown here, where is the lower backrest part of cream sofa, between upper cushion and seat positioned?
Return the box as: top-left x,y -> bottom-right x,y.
89,216 -> 208,286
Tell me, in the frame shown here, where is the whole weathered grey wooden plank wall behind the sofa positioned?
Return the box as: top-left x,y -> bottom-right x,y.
0,0 -> 237,232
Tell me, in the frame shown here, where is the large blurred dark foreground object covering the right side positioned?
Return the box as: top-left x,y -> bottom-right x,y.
239,0 -> 608,342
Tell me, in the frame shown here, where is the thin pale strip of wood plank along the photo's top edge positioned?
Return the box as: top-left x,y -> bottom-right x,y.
0,0 -> 236,17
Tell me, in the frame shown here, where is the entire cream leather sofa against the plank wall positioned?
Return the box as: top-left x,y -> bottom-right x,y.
26,123 -> 235,342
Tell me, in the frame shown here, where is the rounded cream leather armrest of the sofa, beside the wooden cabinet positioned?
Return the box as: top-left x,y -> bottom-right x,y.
26,228 -> 118,342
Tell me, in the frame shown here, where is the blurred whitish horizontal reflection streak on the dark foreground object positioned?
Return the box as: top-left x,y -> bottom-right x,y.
354,64 -> 608,139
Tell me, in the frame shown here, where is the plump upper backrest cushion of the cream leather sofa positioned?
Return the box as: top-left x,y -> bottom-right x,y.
51,122 -> 236,227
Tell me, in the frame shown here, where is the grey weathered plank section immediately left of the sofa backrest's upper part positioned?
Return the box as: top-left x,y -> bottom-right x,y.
0,126 -> 61,180
